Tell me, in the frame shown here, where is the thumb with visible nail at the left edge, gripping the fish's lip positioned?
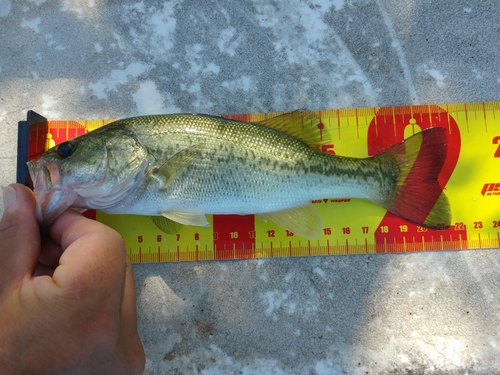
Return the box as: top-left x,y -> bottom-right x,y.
0,184 -> 40,291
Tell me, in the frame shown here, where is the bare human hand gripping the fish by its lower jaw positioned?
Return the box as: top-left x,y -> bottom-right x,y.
0,184 -> 145,374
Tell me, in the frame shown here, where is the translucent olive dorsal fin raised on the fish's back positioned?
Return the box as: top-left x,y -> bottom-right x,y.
257,111 -> 330,147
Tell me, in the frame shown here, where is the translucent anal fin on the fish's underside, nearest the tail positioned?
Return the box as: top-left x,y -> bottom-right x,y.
259,203 -> 321,239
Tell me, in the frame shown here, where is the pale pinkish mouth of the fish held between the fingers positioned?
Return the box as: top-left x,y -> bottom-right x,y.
27,159 -> 78,229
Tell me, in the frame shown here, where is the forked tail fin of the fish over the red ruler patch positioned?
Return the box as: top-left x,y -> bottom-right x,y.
375,127 -> 451,229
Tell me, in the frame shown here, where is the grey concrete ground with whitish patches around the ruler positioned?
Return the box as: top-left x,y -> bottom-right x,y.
0,0 -> 500,375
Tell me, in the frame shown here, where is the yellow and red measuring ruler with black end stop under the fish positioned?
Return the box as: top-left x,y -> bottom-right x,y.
18,102 -> 500,263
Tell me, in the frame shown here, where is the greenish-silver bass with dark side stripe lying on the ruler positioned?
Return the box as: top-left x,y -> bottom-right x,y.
28,111 -> 451,238
